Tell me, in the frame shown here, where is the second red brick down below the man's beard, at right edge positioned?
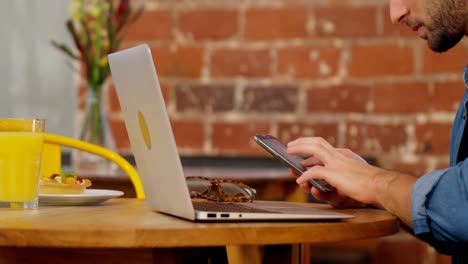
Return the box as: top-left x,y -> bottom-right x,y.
432,80 -> 466,111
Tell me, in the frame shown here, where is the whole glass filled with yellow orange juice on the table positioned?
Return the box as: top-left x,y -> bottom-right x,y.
0,118 -> 45,209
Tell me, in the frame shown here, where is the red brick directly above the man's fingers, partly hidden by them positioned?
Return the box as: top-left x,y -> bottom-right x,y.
278,122 -> 338,147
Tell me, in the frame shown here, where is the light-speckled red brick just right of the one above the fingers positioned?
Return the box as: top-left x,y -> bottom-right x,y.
345,122 -> 407,155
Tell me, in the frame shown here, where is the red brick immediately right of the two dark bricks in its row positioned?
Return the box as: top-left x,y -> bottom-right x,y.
307,84 -> 369,113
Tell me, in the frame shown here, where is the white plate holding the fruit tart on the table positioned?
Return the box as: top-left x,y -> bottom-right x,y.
39,189 -> 124,205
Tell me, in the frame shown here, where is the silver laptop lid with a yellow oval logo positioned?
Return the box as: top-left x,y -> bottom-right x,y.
108,45 -> 195,220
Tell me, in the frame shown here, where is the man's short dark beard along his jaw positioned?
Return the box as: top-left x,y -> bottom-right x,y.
426,0 -> 466,52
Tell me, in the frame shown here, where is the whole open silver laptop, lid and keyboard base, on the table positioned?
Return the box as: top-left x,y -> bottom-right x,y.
108,44 -> 353,221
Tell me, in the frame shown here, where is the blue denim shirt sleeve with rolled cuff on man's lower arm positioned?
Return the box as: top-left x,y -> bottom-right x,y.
411,161 -> 468,254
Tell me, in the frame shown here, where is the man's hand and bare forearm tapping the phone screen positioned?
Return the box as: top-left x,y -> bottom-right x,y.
288,137 -> 416,225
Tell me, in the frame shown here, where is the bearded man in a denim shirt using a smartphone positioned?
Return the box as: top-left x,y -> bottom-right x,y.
288,0 -> 468,263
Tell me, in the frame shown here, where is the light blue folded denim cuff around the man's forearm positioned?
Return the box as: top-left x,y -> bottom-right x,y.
411,169 -> 448,235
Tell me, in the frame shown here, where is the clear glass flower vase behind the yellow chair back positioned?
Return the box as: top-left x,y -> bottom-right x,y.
72,81 -> 116,175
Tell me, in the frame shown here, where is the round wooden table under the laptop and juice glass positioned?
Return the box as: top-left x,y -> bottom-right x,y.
0,199 -> 398,263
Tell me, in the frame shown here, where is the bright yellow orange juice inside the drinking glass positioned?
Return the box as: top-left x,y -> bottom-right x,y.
0,131 -> 44,202
